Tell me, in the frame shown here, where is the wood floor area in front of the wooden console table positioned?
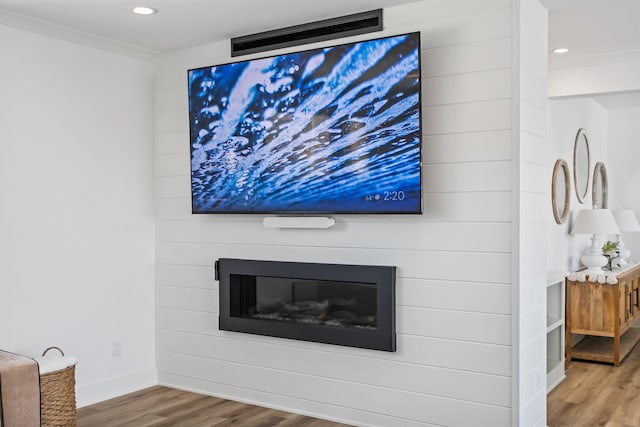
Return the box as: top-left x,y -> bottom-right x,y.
547,344 -> 640,427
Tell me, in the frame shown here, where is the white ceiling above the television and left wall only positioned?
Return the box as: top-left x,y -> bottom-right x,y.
0,0 -> 416,53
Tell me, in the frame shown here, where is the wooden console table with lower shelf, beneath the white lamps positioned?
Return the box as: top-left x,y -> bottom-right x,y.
565,264 -> 640,366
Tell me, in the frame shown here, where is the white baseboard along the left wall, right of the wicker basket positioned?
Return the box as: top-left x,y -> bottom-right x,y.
76,369 -> 158,408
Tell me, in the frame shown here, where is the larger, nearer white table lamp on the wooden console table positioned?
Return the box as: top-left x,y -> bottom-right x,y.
571,209 -> 620,275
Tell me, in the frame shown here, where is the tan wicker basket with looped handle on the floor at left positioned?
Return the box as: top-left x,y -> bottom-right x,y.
40,347 -> 77,427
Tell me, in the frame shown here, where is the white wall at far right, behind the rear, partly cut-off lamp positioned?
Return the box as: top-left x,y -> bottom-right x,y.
606,107 -> 640,262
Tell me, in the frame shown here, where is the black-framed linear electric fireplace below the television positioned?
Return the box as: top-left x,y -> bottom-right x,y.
215,258 -> 396,351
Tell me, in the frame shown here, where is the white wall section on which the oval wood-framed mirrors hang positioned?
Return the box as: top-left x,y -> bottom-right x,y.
545,98 -> 616,271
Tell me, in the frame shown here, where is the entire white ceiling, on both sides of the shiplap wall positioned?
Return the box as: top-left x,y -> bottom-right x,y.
0,0 -> 640,107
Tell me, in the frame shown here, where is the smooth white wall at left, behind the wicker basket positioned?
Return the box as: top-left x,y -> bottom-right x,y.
0,26 -> 156,406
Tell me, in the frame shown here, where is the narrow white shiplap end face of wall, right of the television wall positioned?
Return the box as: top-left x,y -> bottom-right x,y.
513,0 -> 548,427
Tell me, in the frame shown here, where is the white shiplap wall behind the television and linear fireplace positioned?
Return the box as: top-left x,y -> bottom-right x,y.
156,0 -> 518,426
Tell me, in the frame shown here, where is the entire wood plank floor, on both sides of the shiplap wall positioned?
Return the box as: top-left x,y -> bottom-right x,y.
78,345 -> 640,427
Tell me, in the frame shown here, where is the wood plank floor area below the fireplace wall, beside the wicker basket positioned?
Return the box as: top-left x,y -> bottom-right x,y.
78,386 -> 348,427
